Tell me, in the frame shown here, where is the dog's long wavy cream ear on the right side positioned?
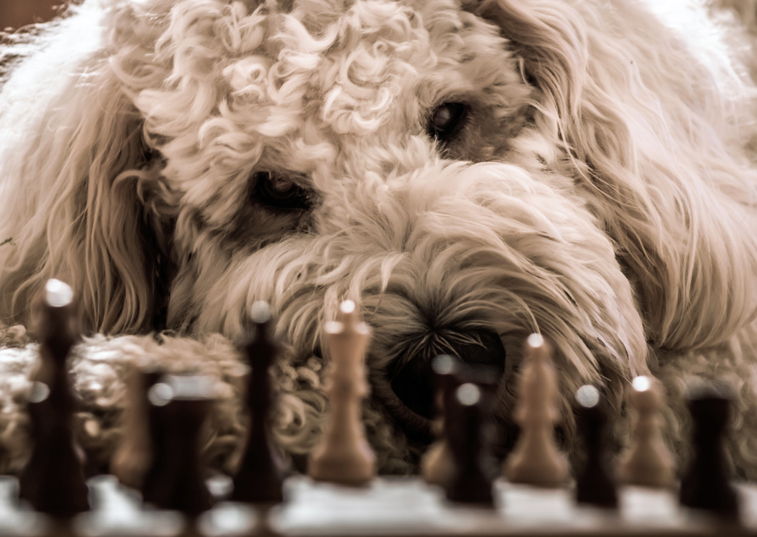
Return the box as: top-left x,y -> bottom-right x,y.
472,0 -> 757,350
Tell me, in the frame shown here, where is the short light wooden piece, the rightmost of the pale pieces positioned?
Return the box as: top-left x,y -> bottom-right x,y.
618,377 -> 675,488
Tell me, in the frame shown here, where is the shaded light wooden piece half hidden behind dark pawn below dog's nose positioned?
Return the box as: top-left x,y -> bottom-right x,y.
421,354 -> 461,487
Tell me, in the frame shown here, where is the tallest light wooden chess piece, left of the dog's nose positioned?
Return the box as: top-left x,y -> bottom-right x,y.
308,300 -> 376,485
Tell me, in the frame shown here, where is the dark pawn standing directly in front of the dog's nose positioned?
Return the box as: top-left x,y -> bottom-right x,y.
444,382 -> 494,507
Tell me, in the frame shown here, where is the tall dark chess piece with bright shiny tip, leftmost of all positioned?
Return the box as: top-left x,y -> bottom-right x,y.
19,280 -> 89,519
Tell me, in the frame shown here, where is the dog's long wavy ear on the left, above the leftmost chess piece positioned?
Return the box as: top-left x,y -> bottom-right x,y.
0,2 -> 172,332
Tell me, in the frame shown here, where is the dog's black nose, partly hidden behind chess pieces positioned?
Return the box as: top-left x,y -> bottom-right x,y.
389,330 -> 506,420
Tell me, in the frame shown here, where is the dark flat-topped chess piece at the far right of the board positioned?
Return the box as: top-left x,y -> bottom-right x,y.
680,386 -> 739,520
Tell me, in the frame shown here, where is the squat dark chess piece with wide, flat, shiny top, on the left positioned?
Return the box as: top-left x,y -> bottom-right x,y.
142,375 -> 213,517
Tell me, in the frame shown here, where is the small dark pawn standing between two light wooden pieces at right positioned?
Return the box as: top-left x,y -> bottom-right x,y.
576,386 -> 618,509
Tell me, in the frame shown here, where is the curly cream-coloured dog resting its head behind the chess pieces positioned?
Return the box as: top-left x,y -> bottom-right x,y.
0,0 -> 757,479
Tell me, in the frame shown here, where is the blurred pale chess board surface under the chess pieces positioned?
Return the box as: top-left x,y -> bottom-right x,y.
0,476 -> 757,537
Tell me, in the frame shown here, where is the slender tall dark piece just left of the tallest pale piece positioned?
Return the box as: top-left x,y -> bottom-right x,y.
231,302 -> 284,503
